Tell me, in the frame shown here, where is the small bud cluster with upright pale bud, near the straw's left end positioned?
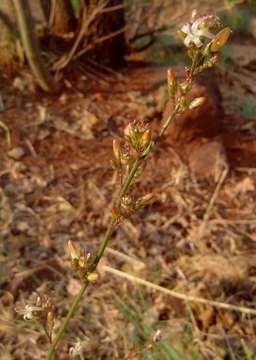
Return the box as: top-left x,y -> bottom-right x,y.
68,240 -> 98,281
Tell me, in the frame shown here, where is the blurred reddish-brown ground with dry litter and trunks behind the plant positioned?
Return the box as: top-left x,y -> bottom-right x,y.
0,0 -> 256,360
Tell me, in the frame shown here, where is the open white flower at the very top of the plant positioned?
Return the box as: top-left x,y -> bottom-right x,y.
181,16 -> 215,48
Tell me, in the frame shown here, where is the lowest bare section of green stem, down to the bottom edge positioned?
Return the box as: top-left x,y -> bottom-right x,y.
46,280 -> 89,360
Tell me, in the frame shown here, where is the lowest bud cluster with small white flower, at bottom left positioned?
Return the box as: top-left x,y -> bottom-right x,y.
16,294 -> 55,342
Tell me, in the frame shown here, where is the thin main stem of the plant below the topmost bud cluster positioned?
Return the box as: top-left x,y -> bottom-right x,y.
46,106 -> 178,360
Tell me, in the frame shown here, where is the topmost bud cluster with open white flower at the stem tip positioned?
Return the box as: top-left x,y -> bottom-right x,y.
167,12 -> 231,112
